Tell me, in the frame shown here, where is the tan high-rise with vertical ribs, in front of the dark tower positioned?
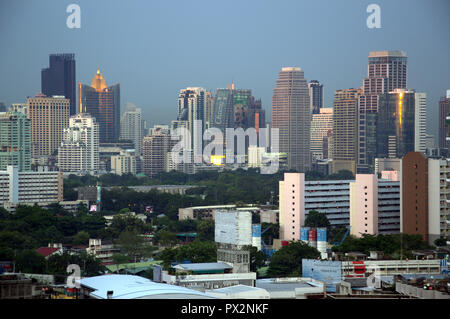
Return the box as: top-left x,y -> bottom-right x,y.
27,94 -> 70,157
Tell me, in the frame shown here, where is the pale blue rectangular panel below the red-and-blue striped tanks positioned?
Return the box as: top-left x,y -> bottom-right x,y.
302,259 -> 342,292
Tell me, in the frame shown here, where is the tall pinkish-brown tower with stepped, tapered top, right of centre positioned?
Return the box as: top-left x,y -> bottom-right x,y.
272,67 -> 311,172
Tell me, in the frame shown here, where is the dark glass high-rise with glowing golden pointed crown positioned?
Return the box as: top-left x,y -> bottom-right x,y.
78,69 -> 120,143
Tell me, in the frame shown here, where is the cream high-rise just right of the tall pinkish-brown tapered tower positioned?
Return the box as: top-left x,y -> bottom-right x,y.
311,108 -> 333,160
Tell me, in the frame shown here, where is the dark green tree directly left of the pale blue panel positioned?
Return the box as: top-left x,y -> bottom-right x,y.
267,241 -> 320,277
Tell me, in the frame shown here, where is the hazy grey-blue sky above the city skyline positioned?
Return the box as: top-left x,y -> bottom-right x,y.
0,0 -> 450,139
